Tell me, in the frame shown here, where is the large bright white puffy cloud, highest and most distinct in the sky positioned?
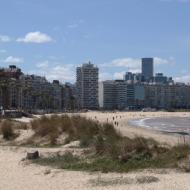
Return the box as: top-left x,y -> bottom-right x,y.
17,31 -> 54,43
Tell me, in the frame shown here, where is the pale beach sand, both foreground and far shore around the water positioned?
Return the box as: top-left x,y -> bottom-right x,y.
0,112 -> 190,190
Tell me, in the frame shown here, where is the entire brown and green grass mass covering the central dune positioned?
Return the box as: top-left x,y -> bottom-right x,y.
31,115 -> 190,172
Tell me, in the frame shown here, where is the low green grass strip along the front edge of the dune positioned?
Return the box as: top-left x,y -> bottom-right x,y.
34,147 -> 190,173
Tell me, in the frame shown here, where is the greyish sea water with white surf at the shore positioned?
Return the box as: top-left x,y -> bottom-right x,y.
129,117 -> 190,135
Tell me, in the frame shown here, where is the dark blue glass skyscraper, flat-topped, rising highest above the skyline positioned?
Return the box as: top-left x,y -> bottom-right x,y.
142,58 -> 154,81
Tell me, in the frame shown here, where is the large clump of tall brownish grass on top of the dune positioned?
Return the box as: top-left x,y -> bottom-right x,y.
31,115 -> 117,147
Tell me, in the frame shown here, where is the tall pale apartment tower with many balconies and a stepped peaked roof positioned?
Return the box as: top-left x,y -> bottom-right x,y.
76,62 -> 99,109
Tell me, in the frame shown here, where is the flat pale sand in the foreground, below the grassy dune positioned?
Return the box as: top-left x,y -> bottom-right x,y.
0,147 -> 190,190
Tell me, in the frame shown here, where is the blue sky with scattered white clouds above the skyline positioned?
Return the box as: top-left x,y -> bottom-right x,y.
0,0 -> 190,82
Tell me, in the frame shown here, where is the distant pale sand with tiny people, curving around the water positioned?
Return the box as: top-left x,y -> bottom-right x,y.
81,112 -> 190,145
